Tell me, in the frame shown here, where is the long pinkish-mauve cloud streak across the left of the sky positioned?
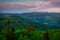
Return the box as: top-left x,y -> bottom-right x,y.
0,4 -> 36,9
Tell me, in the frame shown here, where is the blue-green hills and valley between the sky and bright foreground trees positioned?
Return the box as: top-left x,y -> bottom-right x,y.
0,12 -> 60,29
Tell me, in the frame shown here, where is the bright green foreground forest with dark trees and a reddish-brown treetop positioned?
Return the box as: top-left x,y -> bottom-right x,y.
0,16 -> 60,40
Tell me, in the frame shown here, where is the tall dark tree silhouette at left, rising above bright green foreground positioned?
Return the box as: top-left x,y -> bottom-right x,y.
5,20 -> 16,40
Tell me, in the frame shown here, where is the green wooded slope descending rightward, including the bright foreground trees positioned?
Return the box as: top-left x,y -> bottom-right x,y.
0,12 -> 60,40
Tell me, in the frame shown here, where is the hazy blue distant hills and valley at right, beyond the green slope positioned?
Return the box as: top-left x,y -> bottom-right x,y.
19,12 -> 60,24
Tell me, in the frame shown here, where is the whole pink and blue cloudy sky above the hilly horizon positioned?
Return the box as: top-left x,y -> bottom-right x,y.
0,0 -> 60,13
